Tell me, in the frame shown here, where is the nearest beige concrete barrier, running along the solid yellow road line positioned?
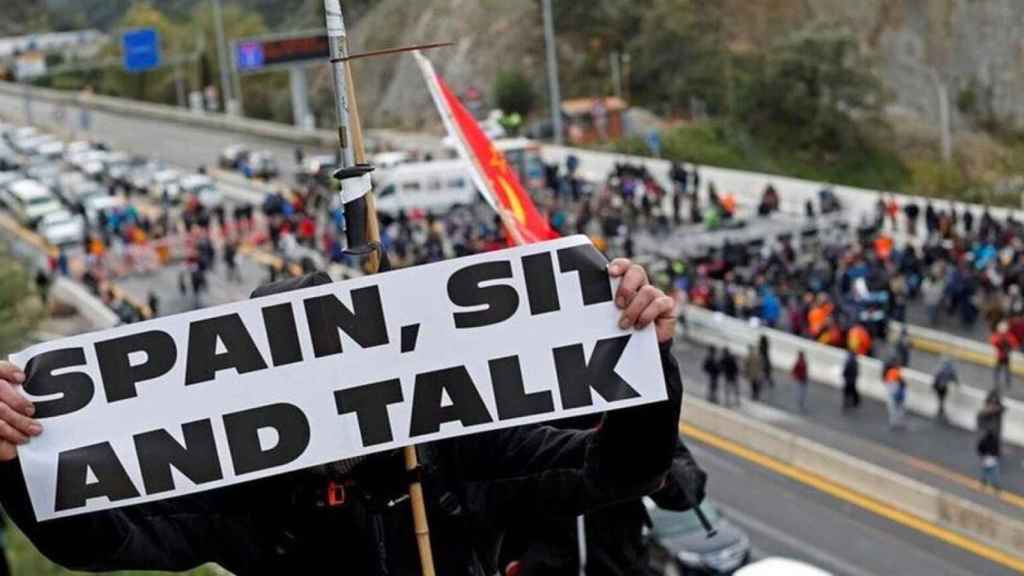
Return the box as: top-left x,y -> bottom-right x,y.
682,395 -> 1024,561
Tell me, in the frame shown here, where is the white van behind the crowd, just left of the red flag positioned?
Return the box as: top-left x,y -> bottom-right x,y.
374,160 -> 477,214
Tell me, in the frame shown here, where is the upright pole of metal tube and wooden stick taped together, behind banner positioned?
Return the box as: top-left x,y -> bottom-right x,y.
324,0 -> 434,576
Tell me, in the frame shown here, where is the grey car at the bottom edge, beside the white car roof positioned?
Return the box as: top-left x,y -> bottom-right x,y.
644,498 -> 751,576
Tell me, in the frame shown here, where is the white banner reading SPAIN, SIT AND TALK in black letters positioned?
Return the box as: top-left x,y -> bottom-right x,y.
11,231 -> 666,520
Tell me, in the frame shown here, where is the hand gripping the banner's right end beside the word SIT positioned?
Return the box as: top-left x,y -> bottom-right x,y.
608,258 -> 676,343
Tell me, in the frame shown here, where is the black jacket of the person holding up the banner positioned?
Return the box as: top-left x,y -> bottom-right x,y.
0,274 -> 682,576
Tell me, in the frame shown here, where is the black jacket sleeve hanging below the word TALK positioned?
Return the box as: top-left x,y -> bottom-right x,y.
450,344 -> 682,525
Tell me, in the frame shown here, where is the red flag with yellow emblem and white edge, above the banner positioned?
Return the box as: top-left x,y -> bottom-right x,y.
413,50 -> 559,244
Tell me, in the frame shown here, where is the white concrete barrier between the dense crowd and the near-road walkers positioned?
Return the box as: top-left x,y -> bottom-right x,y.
683,305 -> 1024,446
